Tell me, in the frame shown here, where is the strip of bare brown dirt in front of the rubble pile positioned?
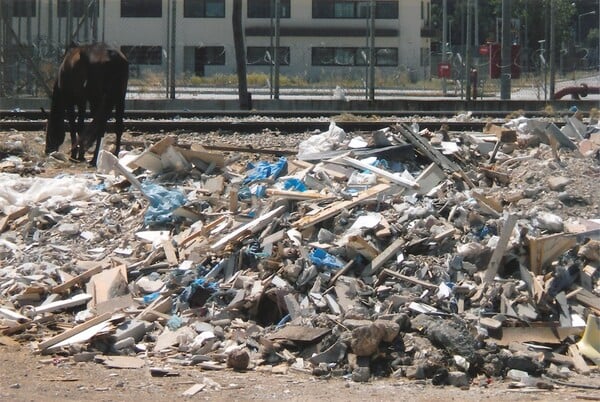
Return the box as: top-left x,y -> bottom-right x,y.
0,347 -> 600,402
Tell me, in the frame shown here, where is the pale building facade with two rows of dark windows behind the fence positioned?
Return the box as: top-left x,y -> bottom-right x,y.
0,0 -> 431,81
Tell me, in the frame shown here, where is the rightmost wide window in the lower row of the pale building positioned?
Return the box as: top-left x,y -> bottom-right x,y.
312,47 -> 398,66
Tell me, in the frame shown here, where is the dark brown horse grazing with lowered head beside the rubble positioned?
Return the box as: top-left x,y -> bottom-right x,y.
46,43 -> 129,165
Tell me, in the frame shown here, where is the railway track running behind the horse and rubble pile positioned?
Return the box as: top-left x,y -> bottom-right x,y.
0,110 -> 564,133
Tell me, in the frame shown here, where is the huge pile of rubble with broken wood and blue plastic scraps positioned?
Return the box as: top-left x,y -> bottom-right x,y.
0,111 -> 600,388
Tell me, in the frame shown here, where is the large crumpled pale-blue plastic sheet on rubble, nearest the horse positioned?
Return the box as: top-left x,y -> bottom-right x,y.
142,182 -> 186,225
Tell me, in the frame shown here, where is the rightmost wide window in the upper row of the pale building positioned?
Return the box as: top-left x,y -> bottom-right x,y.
312,0 -> 399,19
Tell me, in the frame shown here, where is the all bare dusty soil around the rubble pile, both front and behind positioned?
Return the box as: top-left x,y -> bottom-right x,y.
0,126 -> 600,402
